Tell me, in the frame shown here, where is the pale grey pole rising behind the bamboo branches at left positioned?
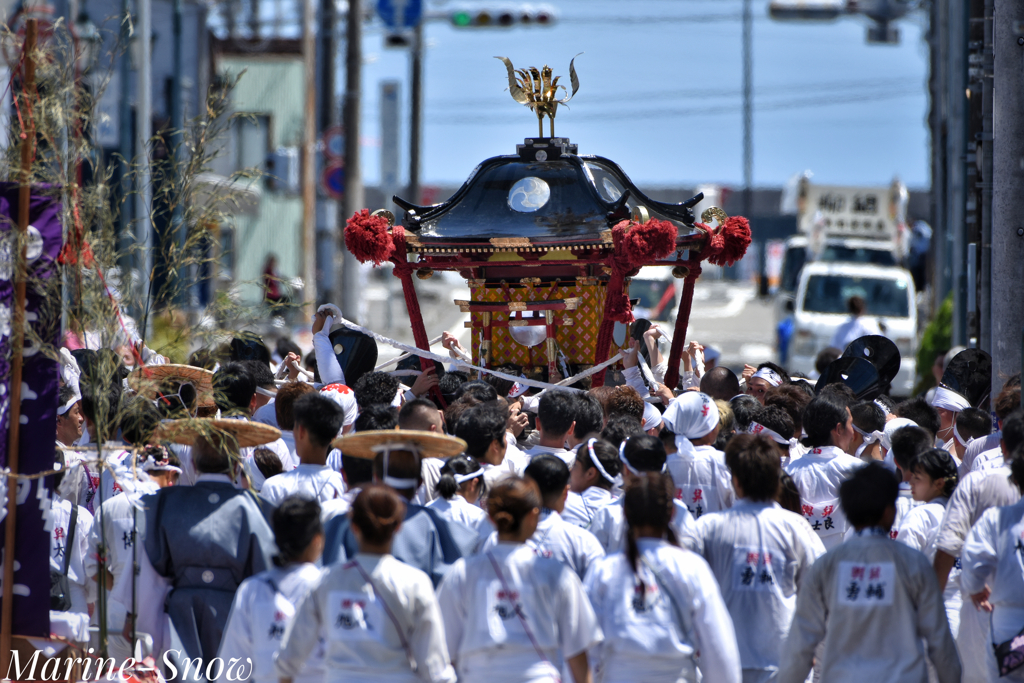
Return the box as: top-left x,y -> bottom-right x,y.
135,0 -> 154,339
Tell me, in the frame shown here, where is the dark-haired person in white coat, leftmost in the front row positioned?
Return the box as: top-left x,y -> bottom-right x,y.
217,496 -> 324,683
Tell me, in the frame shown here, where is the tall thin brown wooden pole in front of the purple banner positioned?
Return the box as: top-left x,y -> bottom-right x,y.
0,19 -> 38,676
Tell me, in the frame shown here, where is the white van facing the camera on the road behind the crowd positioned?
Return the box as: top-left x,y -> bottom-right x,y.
787,262 -> 918,396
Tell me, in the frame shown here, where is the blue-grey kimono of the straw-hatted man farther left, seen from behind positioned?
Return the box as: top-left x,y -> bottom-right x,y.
142,475 -> 275,676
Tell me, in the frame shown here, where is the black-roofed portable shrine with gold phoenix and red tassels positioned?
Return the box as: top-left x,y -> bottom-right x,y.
345,57 -> 751,386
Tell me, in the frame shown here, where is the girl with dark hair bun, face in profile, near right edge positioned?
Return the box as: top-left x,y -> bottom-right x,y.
893,449 -> 964,638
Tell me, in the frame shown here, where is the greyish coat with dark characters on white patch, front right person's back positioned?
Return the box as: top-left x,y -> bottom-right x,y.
778,529 -> 961,683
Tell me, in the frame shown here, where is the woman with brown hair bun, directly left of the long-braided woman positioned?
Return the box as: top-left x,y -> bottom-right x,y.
437,476 -> 601,683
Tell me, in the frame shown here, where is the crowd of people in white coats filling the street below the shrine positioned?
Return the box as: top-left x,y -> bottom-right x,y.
51,312 -> 1024,683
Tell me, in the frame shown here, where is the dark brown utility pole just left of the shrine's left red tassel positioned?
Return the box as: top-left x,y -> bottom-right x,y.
341,0 -> 366,319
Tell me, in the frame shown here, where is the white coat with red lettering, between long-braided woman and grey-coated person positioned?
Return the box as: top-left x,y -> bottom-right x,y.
693,499 -> 825,672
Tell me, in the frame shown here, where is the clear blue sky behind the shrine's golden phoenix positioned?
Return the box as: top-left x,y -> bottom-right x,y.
362,0 -> 929,187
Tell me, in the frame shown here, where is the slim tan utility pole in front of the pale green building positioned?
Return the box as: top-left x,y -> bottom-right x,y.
301,0 -> 316,316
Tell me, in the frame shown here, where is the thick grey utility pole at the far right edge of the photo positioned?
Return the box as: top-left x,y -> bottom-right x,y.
985,0 -> 1024,396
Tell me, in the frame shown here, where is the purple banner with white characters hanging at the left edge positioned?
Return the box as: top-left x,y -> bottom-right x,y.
0,182 -> 62,638
